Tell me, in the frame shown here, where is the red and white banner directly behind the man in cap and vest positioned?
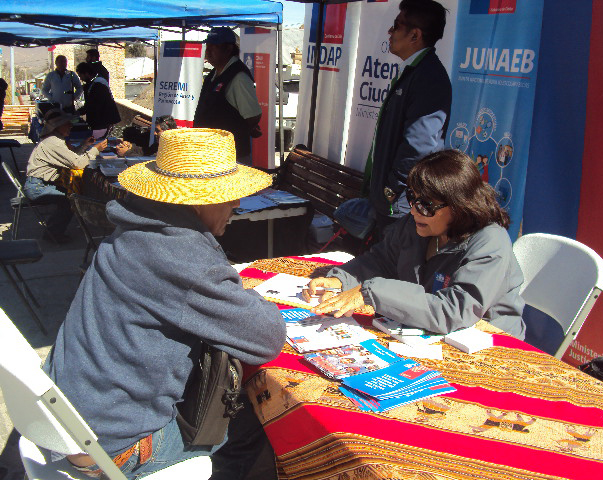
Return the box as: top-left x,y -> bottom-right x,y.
241,27 -> 276,168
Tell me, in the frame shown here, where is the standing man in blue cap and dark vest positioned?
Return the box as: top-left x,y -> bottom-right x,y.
193,27 -> 262,165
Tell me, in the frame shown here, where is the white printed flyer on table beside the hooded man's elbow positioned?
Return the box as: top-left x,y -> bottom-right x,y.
287,315 -> 376,353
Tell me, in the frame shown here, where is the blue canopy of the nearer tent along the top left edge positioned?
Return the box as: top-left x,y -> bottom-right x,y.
0,0 -> 283,32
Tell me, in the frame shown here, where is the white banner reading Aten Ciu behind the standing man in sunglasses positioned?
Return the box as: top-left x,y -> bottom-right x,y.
345,0 -> 457,171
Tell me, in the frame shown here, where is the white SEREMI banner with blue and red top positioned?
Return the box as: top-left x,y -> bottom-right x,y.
153,40 -> 205,127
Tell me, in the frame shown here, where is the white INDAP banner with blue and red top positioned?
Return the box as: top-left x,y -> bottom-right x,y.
295,2 -> 361,163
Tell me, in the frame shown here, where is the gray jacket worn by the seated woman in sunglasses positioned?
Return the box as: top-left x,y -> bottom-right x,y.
328,214 -> 525,339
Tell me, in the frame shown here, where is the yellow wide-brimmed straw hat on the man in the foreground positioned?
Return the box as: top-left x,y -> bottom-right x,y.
119,128 -> 272,205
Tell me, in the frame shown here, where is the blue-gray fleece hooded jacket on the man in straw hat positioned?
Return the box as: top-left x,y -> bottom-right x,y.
46,196 -> 285,455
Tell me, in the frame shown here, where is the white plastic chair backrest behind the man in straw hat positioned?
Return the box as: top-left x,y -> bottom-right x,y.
0,309 -> 89,454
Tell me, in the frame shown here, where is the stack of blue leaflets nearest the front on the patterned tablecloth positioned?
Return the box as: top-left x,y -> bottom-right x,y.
339,359 -> 455,412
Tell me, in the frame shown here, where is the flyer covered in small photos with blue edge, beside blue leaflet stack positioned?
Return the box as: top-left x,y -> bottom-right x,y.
304,340 -> 402,380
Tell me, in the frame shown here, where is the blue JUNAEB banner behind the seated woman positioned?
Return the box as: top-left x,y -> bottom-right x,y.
447,0 -> 543,240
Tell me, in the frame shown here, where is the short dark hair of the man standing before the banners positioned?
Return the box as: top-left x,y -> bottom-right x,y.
400,0 -> 448,47
